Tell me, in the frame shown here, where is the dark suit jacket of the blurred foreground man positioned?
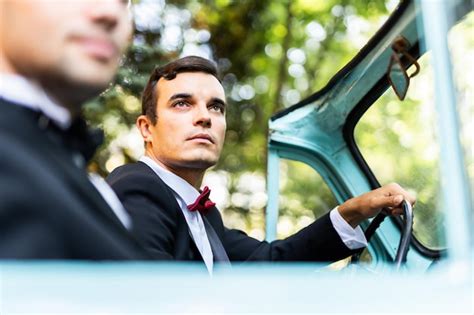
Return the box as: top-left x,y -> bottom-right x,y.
0,99 -> 149,260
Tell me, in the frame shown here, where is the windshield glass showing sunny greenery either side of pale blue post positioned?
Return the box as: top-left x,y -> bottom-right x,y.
355,13 -> 474,249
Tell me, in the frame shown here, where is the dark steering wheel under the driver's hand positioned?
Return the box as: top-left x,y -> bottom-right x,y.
352,200 -> 413,270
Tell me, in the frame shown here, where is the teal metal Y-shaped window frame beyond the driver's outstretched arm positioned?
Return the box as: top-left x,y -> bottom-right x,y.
267,3 -> 431,270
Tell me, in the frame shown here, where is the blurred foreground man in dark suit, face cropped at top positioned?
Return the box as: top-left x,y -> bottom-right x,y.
0,0 -> 149,260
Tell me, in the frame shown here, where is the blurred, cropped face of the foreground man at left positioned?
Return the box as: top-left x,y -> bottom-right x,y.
0,0 -> 131,106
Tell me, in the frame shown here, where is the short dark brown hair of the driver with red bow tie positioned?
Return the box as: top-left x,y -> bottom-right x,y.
142,56 -> 220,124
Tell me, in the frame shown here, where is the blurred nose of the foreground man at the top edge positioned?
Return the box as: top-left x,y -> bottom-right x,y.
89,0 -> 128,31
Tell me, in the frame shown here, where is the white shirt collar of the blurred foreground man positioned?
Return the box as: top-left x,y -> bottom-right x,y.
0,73 -> 71,129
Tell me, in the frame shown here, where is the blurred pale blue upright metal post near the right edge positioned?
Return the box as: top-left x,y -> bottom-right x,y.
421,0 -> 472,262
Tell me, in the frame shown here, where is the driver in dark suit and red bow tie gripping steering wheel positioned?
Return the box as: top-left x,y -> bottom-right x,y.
107,57 -> 414,272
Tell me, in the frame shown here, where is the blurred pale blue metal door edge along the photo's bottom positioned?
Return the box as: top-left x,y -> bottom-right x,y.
0,262 -> 472,314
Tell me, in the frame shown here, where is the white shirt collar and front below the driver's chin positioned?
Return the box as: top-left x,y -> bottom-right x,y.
140,156 -> 214,274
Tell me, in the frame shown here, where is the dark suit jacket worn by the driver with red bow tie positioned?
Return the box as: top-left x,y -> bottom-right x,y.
107,162 -> 353,261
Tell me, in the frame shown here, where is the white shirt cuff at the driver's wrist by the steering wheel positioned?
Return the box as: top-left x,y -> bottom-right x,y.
329,207 -> 367,249
